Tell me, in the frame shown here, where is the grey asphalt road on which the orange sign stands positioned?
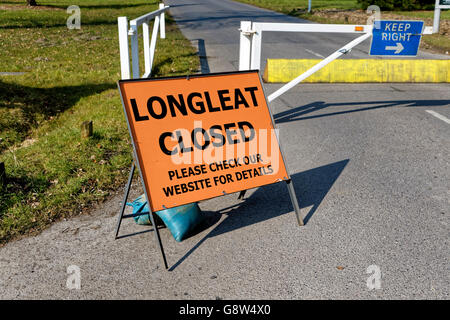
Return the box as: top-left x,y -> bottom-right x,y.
0,0 -> 450,299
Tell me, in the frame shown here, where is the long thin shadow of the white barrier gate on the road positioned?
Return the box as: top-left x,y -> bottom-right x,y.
273,100 -> 450,123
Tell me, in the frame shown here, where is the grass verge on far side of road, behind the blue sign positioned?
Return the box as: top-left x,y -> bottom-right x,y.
238,0 -> 450,54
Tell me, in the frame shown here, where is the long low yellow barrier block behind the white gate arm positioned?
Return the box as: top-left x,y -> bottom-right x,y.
263,59 -> 450,83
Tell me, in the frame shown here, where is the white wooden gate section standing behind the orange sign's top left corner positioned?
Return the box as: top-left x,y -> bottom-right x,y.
117,3 -> 169,80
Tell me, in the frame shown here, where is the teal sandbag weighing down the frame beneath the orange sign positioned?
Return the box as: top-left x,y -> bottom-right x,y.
127,195 -> 202,242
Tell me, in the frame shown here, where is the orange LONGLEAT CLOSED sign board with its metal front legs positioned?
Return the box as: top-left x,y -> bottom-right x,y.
118,71 -> 303,268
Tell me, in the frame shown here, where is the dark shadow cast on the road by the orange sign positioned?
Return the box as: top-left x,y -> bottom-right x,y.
169,159 -> 349,271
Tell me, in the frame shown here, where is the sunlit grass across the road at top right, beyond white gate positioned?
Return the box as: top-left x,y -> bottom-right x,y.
237,0 -> 450,53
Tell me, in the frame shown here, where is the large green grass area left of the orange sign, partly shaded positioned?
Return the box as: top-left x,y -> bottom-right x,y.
0,0 -> 199,243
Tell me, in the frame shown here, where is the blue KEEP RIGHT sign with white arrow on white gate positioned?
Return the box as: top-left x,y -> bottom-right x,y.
369,20 -> 423,56
